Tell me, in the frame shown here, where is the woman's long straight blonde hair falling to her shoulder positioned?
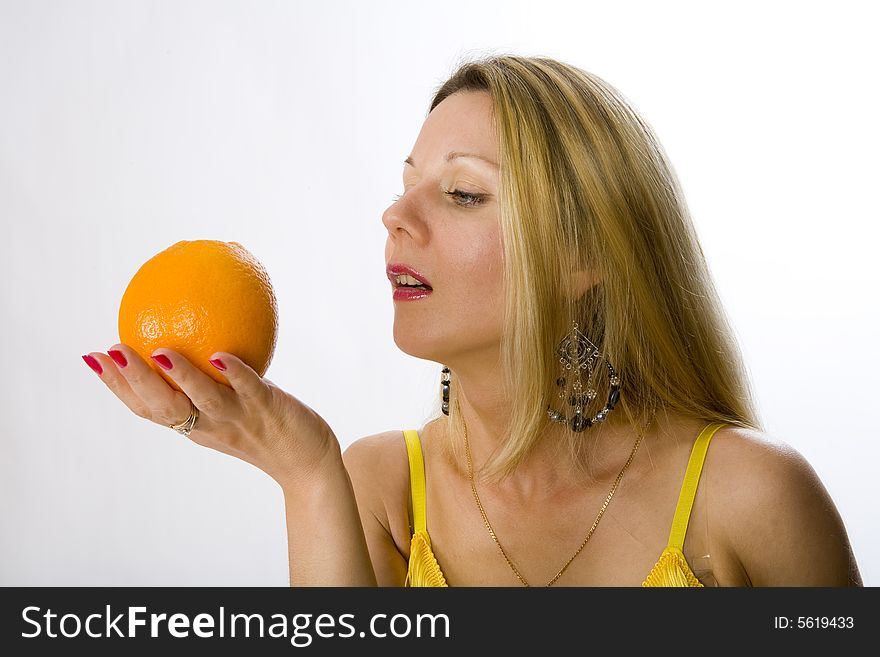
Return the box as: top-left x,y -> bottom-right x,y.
429,55 -> 760,481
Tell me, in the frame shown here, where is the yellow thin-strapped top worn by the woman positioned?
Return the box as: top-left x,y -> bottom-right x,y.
403,423 -> 725,587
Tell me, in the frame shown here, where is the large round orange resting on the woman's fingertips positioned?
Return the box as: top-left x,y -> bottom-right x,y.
119,240 -> 278,390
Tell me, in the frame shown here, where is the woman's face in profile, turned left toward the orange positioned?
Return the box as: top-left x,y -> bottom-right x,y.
382,92 -> 503,364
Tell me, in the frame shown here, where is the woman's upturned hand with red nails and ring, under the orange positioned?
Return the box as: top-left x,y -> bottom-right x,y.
83,344 -> 341,490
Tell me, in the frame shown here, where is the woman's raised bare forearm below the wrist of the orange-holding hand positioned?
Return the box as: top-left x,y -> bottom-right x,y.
282,455 -> 376,586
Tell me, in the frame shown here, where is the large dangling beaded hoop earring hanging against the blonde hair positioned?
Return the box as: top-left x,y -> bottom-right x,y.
547,322 -> 620,433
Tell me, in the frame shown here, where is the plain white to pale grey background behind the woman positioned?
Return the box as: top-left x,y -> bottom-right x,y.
0,0 -> 880,586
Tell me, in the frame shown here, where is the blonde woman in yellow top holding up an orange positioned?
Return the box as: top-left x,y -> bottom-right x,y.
84,56 -> 861,586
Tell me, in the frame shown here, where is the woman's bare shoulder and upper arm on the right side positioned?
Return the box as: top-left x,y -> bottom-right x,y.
701,426 -> 861,586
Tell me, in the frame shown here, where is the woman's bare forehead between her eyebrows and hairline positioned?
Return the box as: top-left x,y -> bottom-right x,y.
407,91 -> 498,167
